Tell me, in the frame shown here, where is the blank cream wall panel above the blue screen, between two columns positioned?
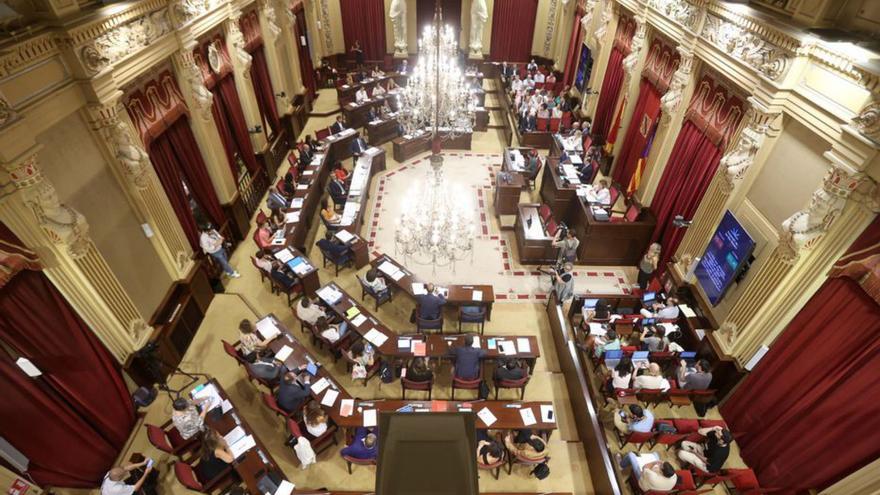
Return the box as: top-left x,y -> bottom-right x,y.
747,120 -> 830,225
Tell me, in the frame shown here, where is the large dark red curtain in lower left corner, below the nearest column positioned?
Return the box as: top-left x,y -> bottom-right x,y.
0,271 -> 135,488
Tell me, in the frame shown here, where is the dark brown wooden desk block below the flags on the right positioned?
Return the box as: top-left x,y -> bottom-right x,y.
565,196 -> 657,266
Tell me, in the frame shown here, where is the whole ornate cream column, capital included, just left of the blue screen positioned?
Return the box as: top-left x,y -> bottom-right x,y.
676,97 -> 781,260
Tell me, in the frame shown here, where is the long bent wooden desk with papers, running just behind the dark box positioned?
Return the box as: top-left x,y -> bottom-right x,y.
257,314 -> 556,434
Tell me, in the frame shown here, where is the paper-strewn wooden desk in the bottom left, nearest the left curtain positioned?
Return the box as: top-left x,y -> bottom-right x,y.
190,378 -> 287,494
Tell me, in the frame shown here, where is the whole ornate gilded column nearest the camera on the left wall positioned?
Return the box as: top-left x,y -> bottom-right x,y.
0,148 -> 150,362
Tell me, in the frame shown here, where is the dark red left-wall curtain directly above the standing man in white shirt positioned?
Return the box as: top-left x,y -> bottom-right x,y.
148,118 -> 226,250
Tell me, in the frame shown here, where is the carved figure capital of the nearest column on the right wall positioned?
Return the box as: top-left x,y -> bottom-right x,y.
779,162 -> 876,264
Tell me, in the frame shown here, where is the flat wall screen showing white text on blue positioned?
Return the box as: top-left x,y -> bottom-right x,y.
694,211 -> 755,306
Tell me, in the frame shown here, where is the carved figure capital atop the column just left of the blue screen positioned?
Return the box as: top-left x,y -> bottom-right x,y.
719,96 -> 780,195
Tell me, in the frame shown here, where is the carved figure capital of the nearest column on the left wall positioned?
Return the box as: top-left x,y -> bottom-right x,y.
3,150 -> 91,259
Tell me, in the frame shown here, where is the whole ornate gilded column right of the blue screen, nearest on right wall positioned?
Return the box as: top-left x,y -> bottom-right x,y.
722,141 -> 880,363
